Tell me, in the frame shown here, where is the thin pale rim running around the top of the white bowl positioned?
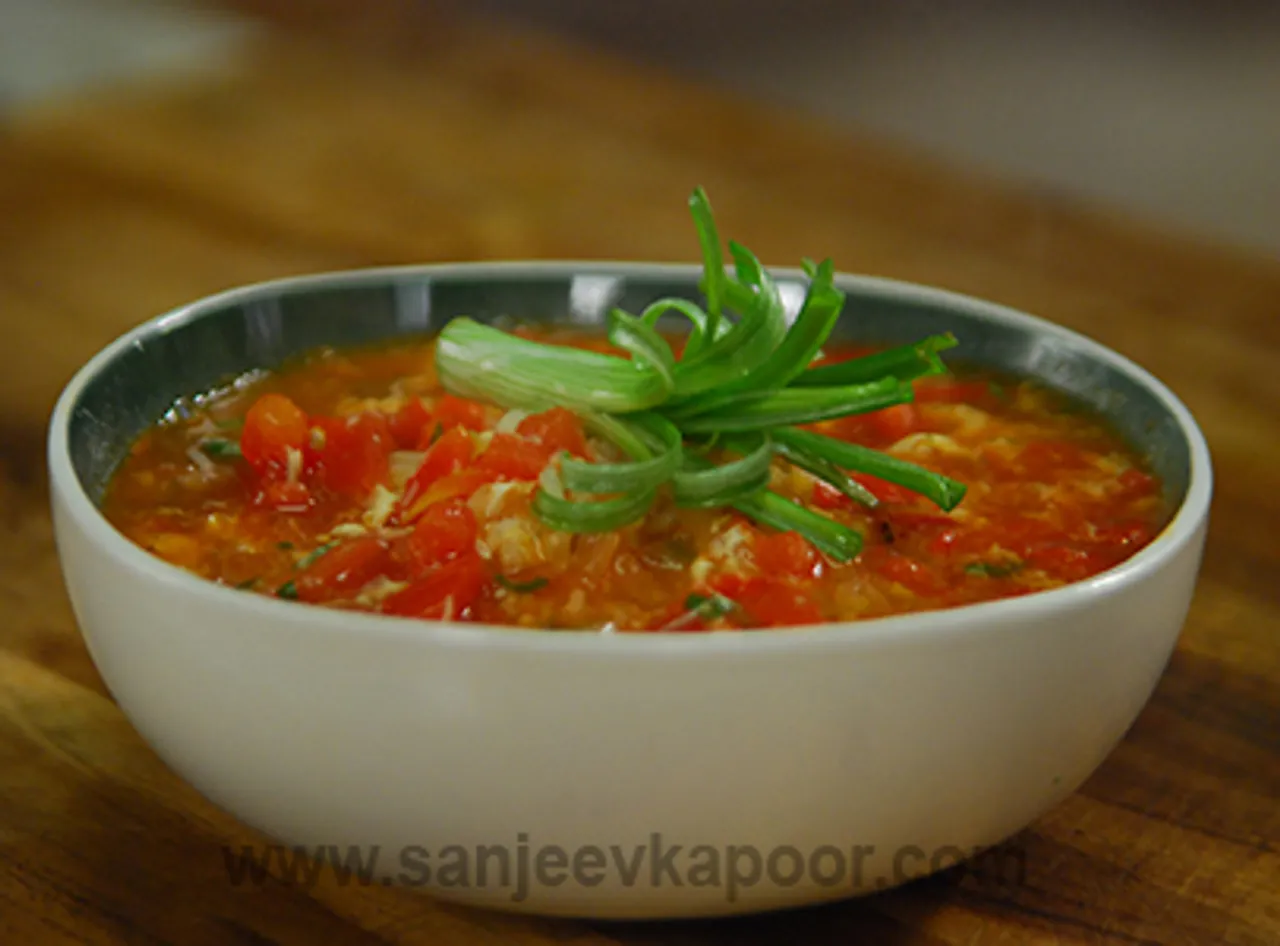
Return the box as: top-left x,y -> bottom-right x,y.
47,260 -> 1213,655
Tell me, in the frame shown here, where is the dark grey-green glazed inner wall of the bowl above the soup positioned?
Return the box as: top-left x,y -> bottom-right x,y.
68,264 -> 1192,509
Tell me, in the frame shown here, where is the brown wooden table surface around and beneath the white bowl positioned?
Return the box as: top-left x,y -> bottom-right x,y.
0,3 -> 1280,946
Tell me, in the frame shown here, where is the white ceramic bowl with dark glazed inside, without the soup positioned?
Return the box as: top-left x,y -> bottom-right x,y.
49,264 -> 1211,918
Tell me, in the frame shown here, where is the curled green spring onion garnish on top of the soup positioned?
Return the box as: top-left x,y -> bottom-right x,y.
432,187 -> 965,563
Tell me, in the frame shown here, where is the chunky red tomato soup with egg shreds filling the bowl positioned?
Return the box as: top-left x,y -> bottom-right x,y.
104,333 -> 1167,631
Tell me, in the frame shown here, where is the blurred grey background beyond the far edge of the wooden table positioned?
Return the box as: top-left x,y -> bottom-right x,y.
0,0 -> 1280,257
